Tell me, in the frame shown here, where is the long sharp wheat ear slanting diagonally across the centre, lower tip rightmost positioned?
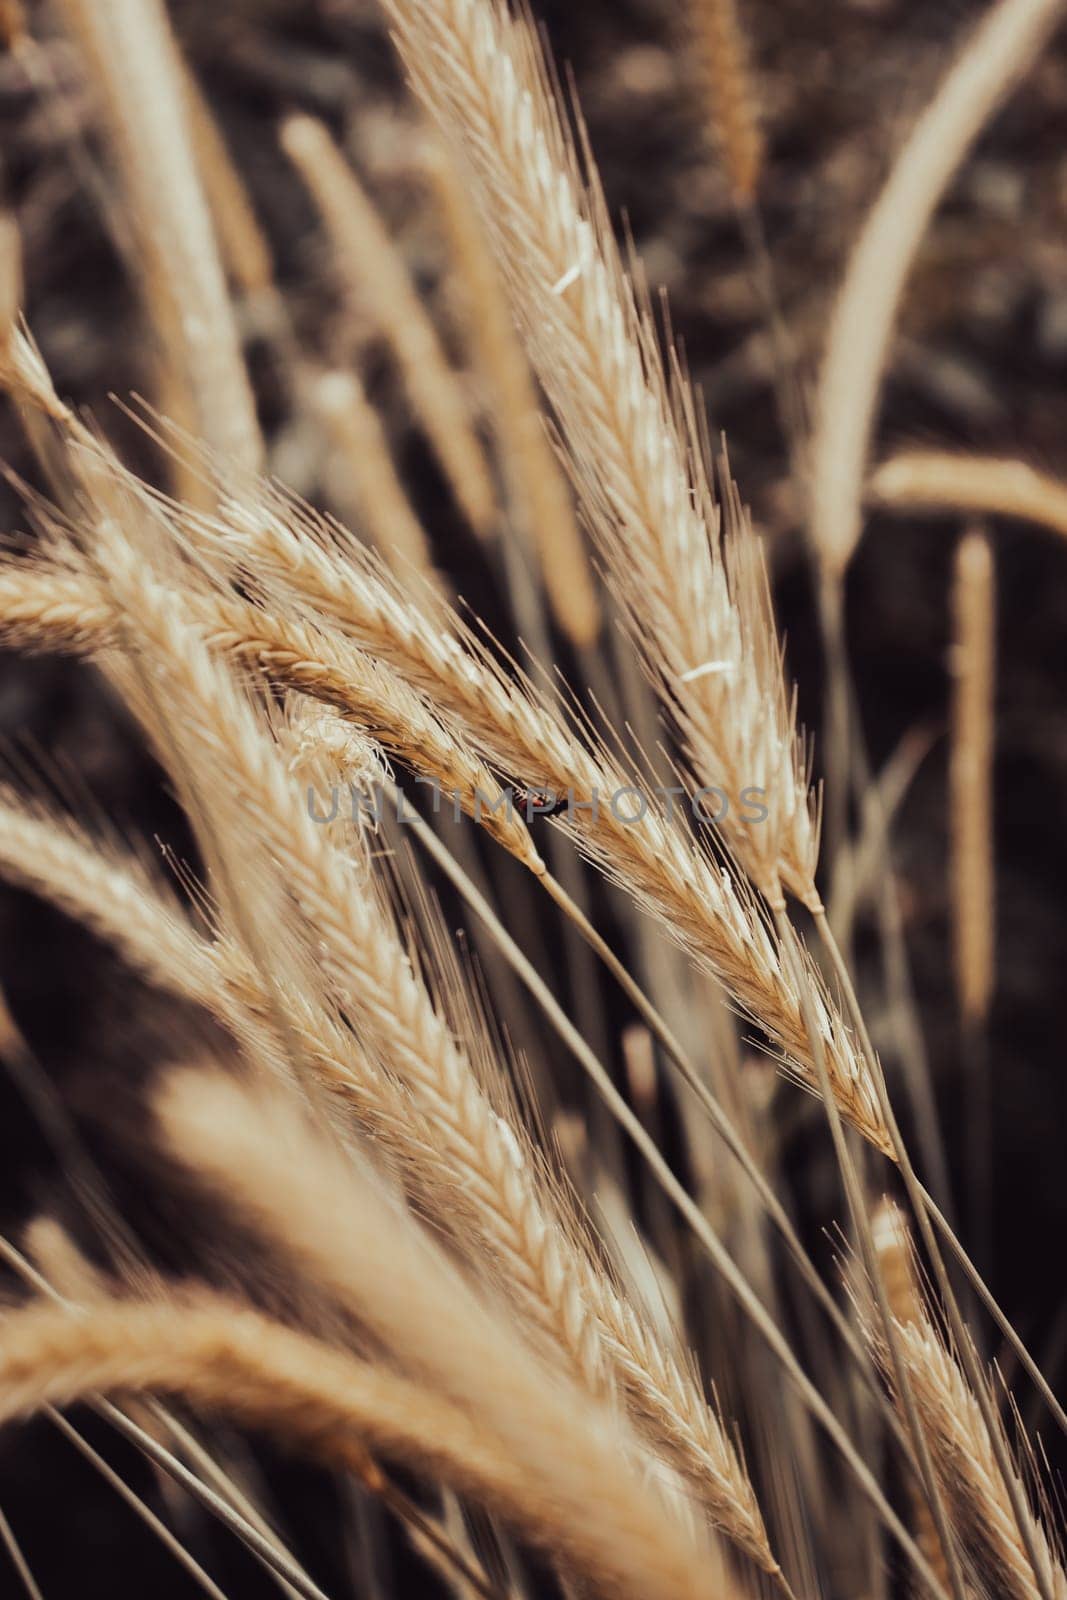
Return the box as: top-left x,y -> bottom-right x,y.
171,480 -> 889,1154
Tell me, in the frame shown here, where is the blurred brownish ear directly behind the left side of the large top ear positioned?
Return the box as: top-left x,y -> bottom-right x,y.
427,144 -> 601,650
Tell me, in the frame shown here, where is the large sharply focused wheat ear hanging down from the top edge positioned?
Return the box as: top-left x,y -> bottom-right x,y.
375,0 -> 817,899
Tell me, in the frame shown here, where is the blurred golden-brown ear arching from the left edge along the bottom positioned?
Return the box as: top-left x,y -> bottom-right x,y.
0,1296 -> 721,1600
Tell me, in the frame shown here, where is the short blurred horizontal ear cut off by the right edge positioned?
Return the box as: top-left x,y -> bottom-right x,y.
867,450 -> 1067,539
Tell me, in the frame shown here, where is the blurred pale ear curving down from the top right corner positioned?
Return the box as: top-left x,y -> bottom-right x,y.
811,0 -> 1062,578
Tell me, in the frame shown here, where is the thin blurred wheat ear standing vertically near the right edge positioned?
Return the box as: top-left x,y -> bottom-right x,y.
949,533 -> 997,1026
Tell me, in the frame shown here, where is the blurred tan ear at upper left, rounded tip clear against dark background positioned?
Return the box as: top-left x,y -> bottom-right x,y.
282,117 -> 496,534
